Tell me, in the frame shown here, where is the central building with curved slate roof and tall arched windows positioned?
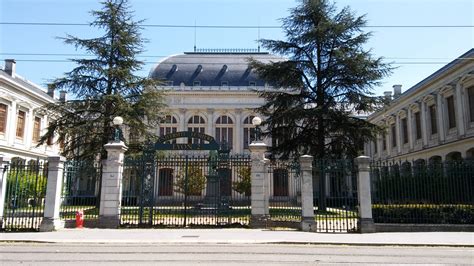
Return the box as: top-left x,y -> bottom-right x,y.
150,50 -> 282,153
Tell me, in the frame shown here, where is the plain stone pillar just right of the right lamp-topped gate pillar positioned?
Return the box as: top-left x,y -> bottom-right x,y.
300,155 -> 316,232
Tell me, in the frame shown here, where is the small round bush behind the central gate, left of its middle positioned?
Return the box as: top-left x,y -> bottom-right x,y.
174,163 -> 206,196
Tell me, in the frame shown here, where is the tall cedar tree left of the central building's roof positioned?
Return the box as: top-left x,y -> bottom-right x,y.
41,0 -> 163,159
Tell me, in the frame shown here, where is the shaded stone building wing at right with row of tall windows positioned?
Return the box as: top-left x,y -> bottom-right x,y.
365,49 -> 474,162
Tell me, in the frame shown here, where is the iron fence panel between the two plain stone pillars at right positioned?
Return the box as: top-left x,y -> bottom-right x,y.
313,159 -> 359,232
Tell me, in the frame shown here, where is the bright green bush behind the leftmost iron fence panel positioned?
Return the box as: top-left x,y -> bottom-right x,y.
6,167 -> 47,208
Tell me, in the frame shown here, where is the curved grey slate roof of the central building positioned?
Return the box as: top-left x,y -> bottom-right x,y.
150,52 -> 283,86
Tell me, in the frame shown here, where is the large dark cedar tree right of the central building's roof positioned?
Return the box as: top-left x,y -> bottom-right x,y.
250,0 -> 391,158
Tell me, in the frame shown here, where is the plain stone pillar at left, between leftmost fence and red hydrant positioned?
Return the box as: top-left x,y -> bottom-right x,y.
40,156 -> 66,232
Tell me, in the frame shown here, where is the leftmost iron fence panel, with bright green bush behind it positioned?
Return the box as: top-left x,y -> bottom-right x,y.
1,160 -> 48,231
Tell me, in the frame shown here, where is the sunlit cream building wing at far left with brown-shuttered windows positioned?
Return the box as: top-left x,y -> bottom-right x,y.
0,59 -> 64,161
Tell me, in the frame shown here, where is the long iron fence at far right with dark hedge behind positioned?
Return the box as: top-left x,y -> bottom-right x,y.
371,160 -> 474,224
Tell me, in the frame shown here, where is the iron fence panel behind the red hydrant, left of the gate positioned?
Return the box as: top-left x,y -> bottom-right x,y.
59,160 -> 102,222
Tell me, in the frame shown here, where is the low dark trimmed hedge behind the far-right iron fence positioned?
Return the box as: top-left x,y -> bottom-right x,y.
372,204 -> 474,224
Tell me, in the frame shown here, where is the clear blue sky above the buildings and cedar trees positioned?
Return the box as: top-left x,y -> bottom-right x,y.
0,0 -> 474,94
